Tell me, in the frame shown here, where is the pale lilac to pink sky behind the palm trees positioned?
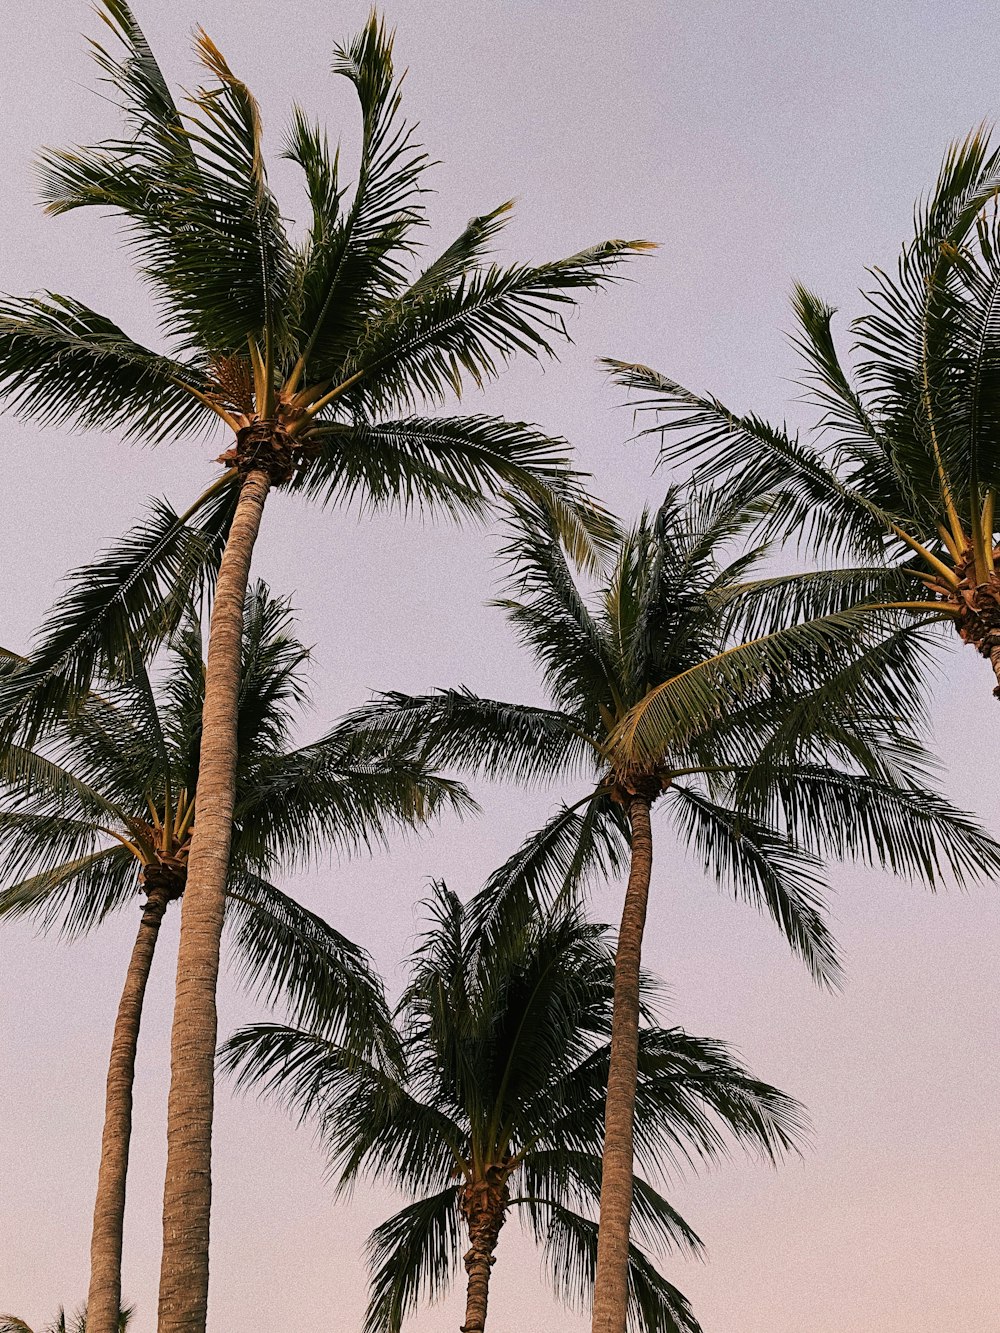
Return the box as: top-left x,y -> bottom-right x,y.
0,0 -> 1000,1333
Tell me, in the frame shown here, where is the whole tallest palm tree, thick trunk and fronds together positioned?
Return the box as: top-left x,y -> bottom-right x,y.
0,0 -> 643,1333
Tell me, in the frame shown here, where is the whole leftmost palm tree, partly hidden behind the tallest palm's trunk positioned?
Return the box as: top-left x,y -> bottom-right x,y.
0,584 -> 467,1333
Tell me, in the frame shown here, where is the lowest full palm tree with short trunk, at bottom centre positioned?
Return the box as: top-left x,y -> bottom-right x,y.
220,884 -> 803,1333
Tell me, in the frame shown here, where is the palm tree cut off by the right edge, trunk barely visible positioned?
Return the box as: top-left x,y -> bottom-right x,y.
605,129 -> 1000,697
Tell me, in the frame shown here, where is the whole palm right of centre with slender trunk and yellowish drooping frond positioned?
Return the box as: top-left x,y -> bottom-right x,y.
344,488 -> 1000,1333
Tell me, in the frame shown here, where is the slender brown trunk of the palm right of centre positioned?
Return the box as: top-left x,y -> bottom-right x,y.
592,793 -> 653,1333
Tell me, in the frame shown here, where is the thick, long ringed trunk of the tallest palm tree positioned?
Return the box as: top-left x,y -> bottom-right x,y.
157,468 -> 271,1333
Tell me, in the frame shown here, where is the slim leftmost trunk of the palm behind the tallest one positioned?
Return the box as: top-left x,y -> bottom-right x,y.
87,893 -> 167,1333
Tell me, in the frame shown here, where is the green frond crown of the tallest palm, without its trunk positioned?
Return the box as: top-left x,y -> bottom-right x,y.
0,0 -> 649,726
